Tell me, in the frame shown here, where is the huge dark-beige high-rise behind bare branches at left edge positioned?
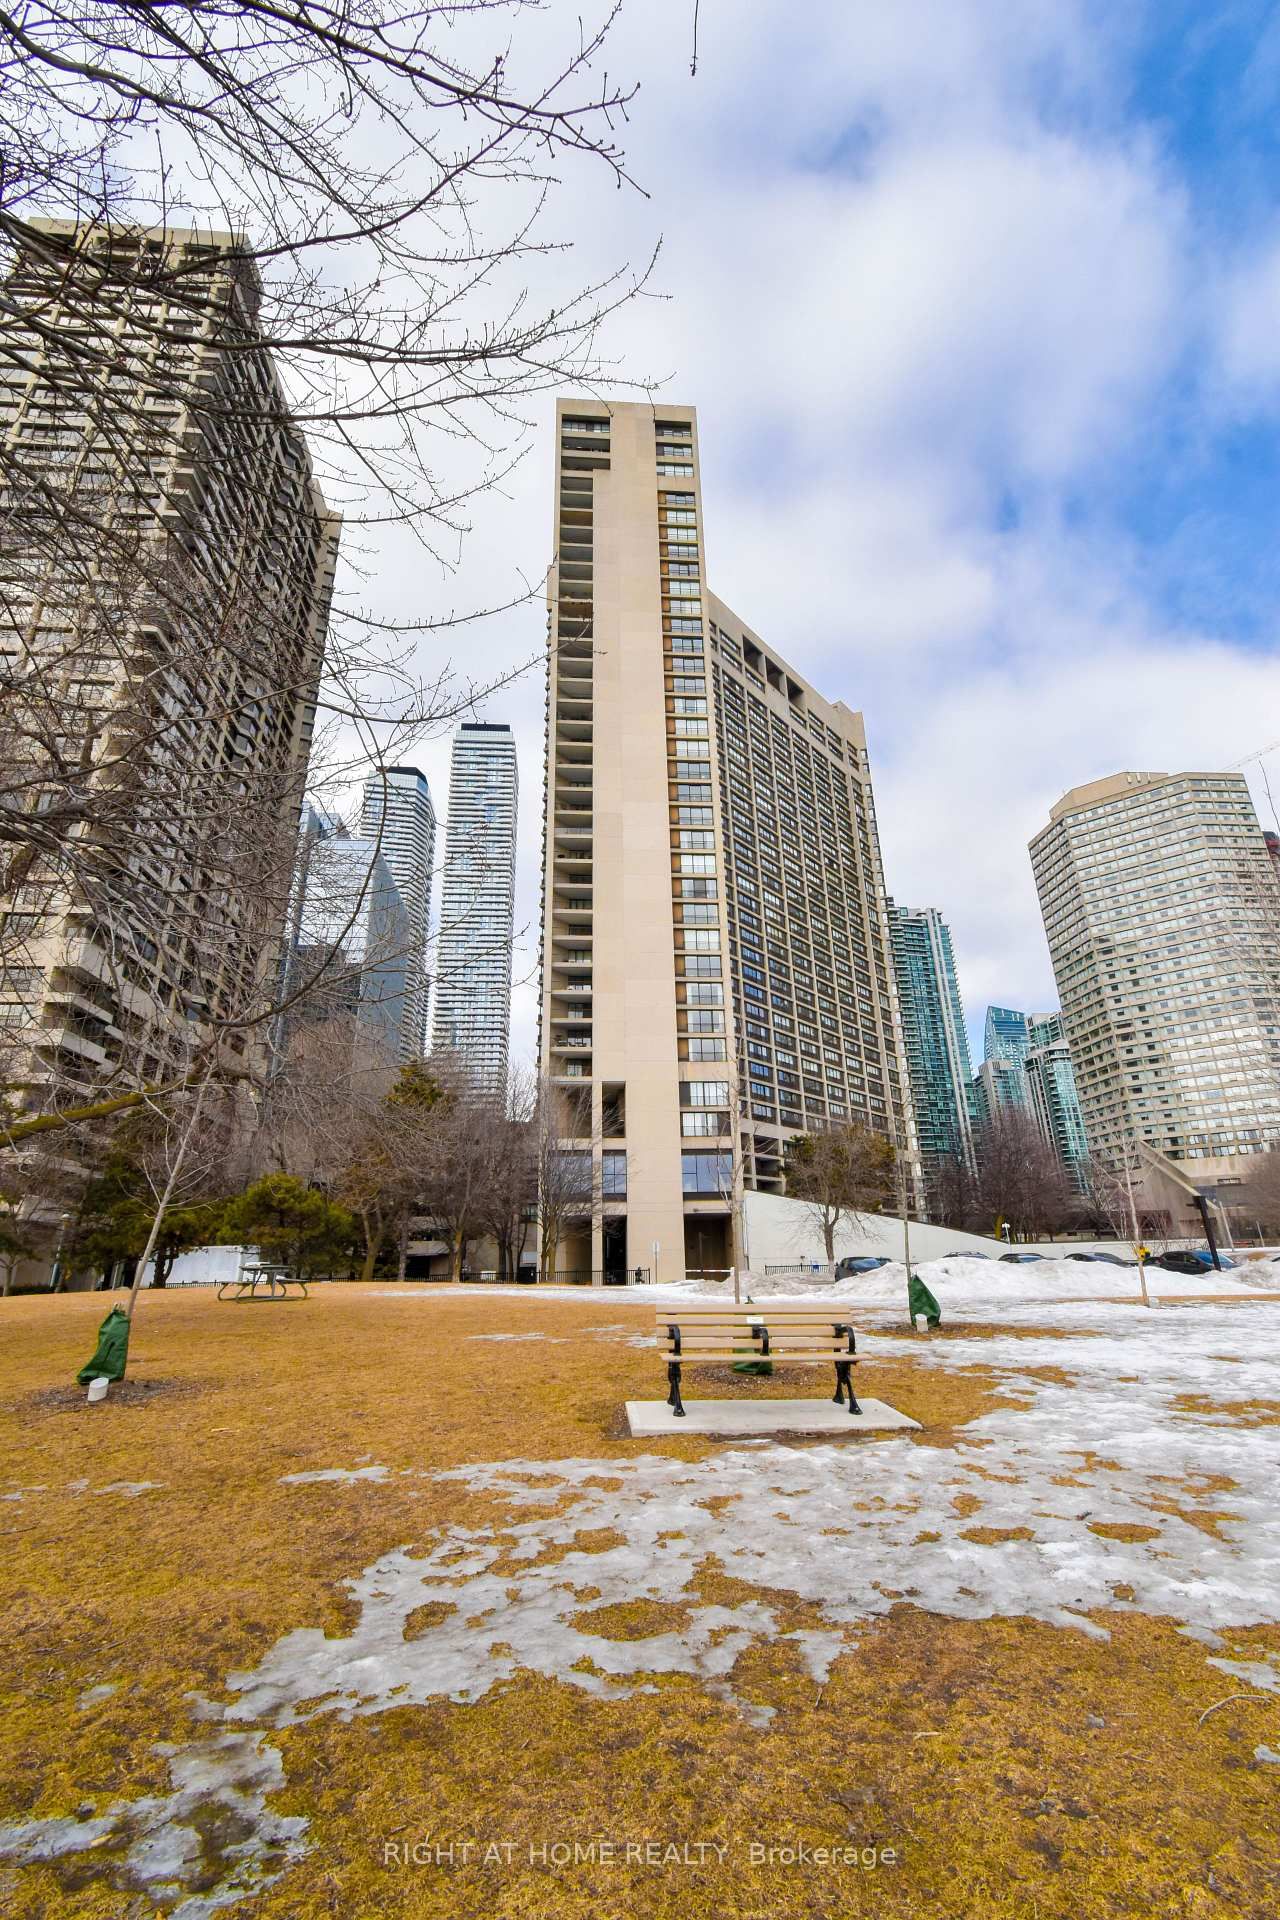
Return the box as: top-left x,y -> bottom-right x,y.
0,221 -> 338,1100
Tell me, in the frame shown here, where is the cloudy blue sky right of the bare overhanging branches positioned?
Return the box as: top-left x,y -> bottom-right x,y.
339,0 -> 1280,1062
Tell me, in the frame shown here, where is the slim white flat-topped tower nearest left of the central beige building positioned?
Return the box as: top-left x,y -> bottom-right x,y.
432,720 -> 518,1096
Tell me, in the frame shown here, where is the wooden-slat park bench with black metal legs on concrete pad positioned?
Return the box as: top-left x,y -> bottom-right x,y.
656,1302 -> 862,1419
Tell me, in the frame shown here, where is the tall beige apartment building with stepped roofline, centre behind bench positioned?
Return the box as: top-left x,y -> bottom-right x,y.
541,399 -> 913,1281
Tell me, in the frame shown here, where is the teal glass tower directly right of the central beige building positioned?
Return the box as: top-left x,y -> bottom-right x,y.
889,900 -> 973,1181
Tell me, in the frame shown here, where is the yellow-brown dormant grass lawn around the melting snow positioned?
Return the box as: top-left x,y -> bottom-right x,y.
0,1286 -> 1280,1920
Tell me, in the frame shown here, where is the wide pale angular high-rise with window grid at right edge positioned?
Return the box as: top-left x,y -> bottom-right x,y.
1031,772 -> 1280,1185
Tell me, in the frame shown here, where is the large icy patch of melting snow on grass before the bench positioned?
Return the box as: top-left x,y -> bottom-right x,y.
0,1297 -> 1280,1920
